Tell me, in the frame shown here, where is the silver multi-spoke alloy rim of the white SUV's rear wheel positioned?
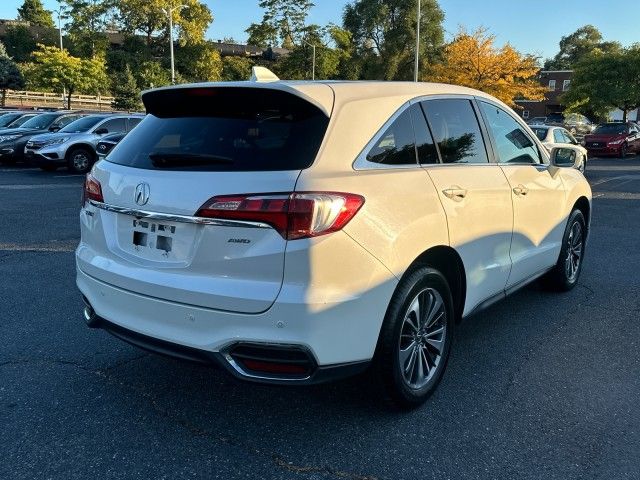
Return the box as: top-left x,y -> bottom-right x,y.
399,288 -> 447,389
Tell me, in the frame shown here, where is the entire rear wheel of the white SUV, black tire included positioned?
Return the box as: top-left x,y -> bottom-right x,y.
370,267 -> 455,409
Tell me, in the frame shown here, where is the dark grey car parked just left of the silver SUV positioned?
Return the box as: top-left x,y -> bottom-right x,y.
0,112 -> 81,164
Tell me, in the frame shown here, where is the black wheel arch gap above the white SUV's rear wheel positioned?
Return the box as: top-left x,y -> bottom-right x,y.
403,245 -> 467,322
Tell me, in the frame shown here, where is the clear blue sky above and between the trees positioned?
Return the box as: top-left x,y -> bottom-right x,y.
0,0 -> 640,58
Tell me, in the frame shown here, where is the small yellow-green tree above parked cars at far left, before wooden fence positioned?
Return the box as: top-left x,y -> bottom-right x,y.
29,45 -> 107,108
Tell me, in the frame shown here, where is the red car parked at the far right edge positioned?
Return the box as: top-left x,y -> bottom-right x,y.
584,122 -> 640,158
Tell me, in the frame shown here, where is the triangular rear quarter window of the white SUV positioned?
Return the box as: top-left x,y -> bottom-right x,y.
367,109 -> 417,165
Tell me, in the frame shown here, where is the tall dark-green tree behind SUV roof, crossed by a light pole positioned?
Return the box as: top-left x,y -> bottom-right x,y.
343,0 -> 444,80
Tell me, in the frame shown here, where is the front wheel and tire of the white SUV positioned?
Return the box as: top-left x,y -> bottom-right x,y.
542,210 -> 587,292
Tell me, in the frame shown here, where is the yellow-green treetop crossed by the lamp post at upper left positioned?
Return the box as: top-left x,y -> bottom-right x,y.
117,0 -> 213,46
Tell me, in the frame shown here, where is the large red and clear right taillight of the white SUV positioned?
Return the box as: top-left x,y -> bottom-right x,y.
196,192 -> 364,240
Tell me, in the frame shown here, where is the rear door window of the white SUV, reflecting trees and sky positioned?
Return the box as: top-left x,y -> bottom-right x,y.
422,99 -> 489,163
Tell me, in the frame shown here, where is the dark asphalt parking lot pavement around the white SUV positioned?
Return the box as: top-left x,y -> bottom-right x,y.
0,157 -> 640,480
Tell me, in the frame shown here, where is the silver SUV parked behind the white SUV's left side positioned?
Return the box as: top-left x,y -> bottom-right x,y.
24,114 -> 143,173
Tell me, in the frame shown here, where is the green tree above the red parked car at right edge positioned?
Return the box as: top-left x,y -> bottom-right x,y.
560,46 -> 640,121
